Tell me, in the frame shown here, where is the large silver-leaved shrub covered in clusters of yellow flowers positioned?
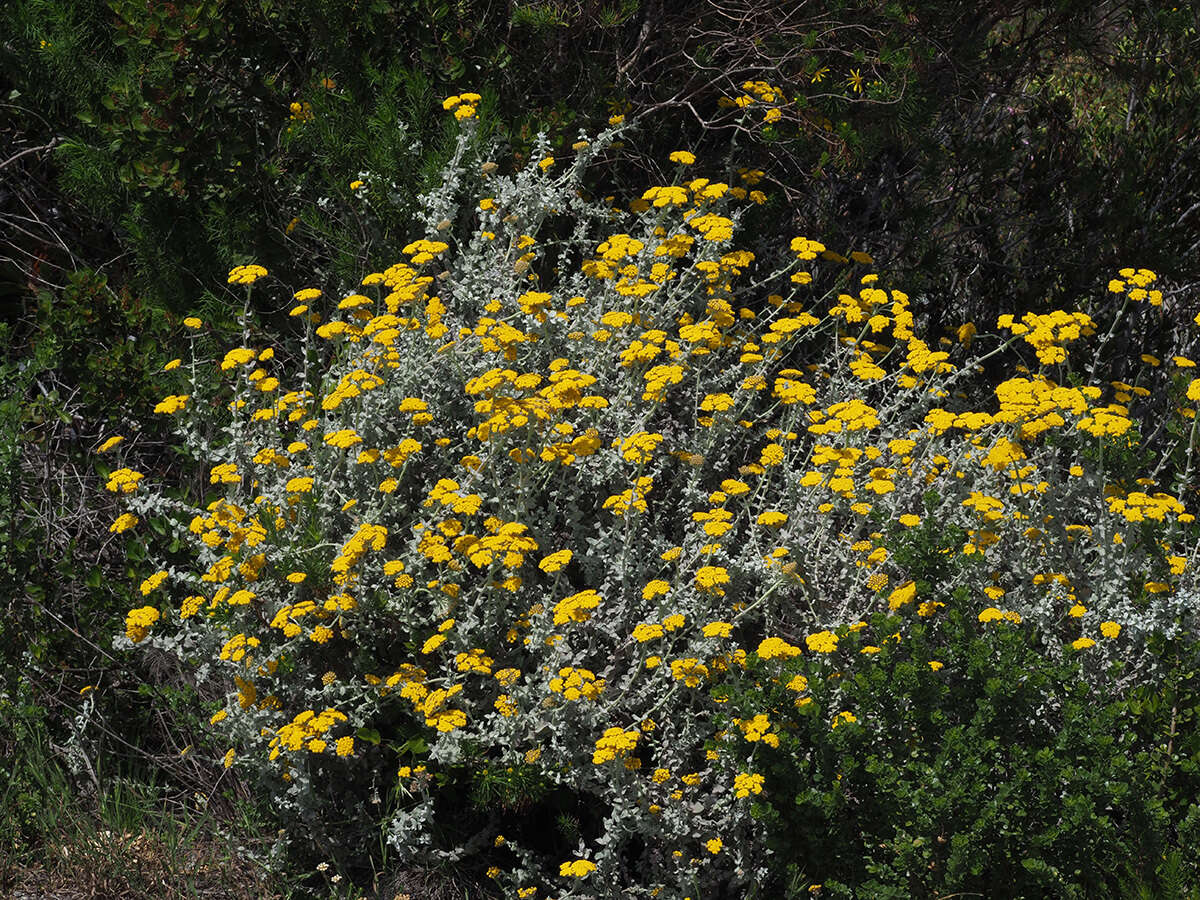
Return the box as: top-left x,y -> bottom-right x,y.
109,102 -> 1196,898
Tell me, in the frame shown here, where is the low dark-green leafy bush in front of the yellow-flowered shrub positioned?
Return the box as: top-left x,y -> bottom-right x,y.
728,602 -> 1196,898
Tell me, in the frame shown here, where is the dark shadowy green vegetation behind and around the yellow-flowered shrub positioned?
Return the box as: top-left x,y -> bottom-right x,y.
0,0 -> 1200,896
